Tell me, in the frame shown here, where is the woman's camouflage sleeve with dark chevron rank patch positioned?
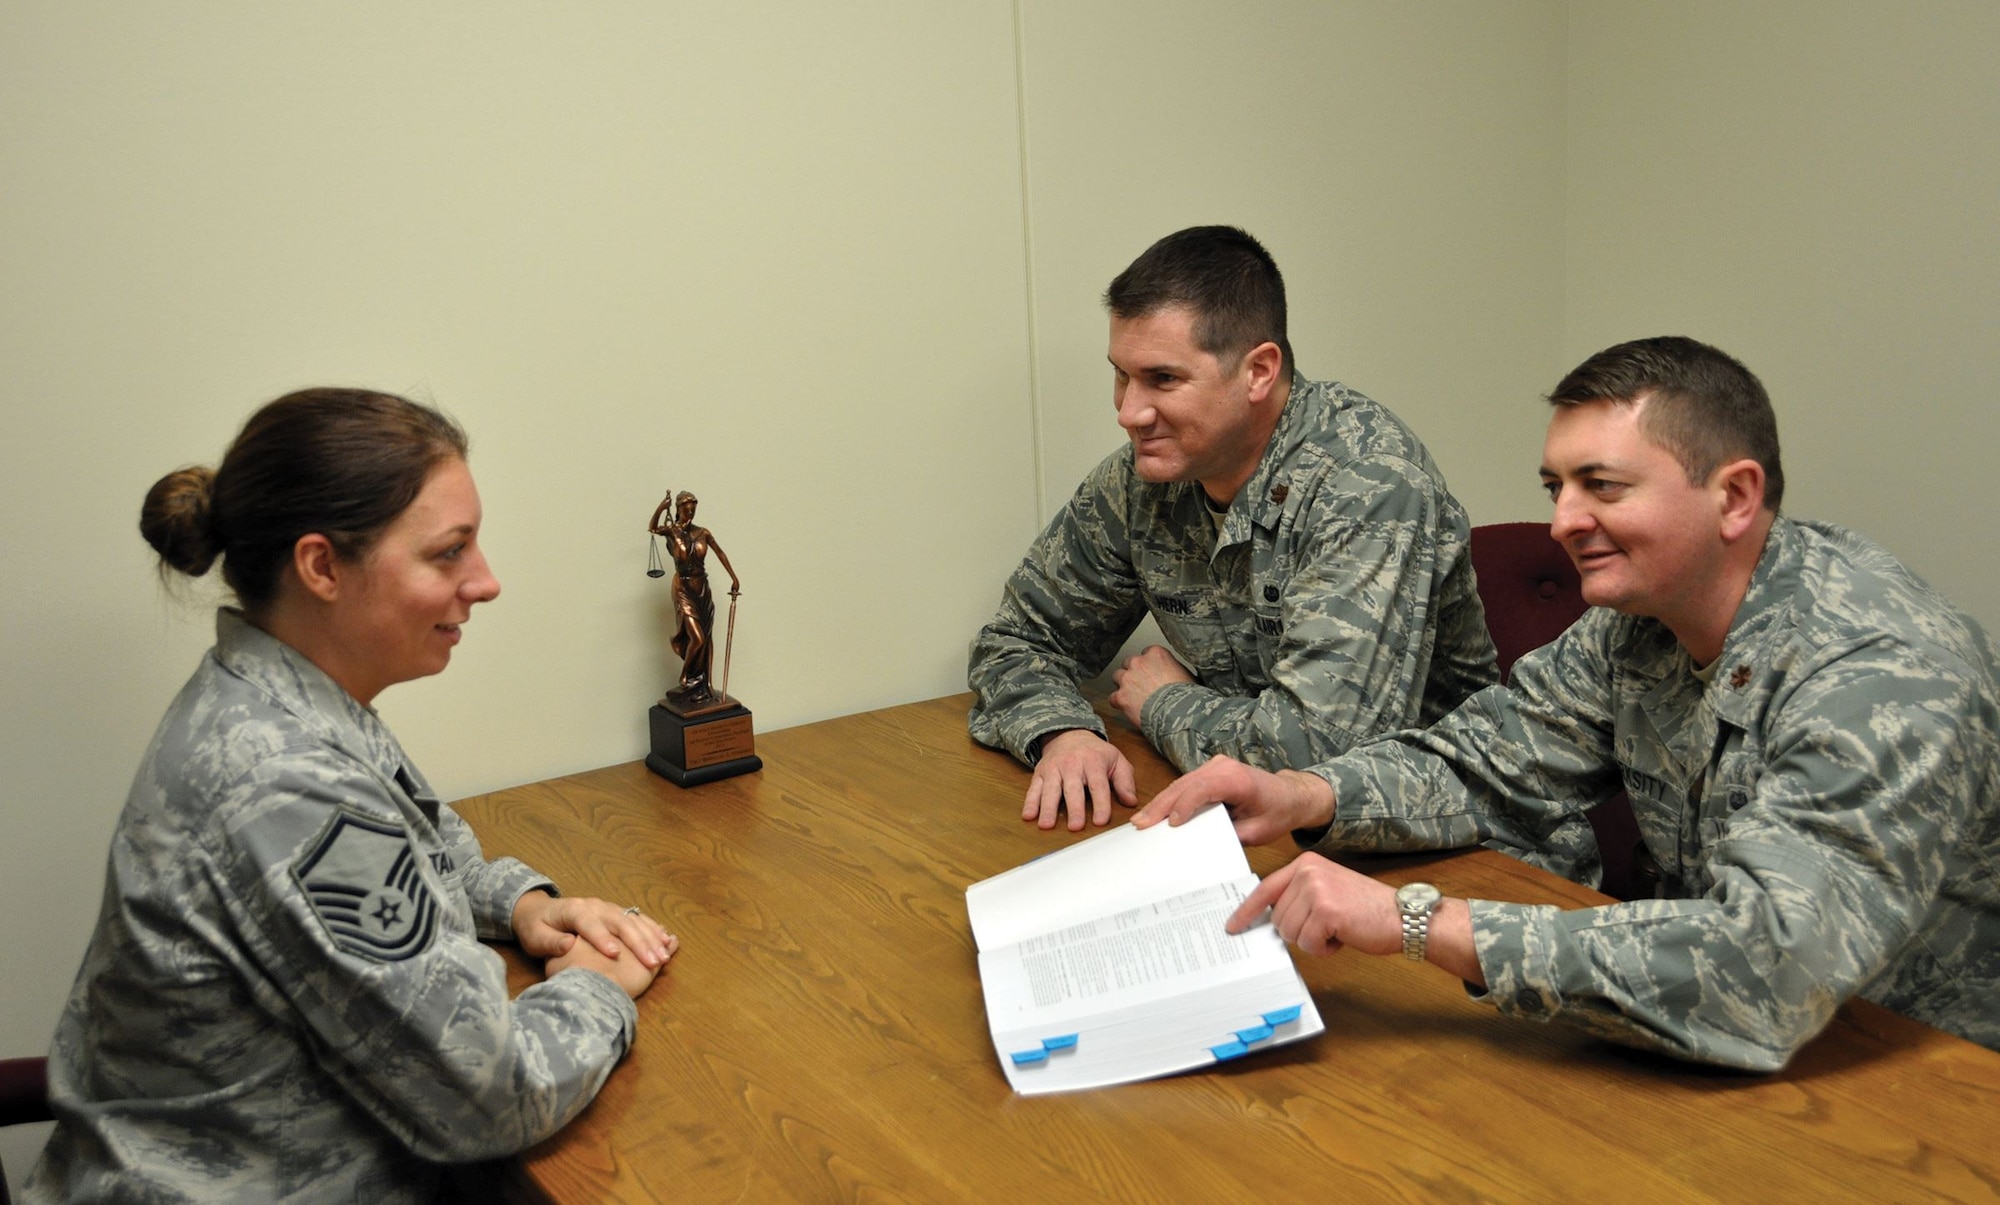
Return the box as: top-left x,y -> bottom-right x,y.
210,753 -> 638,1161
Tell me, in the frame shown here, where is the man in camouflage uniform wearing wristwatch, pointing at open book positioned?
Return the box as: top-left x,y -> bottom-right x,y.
1136,338 -> 2000,1071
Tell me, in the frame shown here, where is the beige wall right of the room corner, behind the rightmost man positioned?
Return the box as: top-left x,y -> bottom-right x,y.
1562,0 -> 2000,631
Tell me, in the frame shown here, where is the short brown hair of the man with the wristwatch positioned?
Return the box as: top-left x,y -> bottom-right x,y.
1548,334 -> 1784,512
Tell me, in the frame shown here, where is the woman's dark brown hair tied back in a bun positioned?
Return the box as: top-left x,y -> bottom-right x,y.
138,388 -> 466,615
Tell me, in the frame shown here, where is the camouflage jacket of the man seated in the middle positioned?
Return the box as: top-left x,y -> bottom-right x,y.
968,372 -> 1498,771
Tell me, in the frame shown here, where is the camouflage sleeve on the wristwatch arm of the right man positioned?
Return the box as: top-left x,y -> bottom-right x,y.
1472,639 -> 1982,1071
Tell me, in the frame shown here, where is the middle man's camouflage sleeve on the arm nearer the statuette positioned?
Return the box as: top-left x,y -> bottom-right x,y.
966,448 -> 1146,763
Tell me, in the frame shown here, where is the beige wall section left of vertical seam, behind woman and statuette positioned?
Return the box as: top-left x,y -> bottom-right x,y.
0,0 -> 1034,1173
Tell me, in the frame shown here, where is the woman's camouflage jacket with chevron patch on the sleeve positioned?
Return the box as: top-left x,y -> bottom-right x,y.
26,611 -> 636,1205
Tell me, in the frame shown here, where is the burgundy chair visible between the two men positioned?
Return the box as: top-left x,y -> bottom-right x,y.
1472,522 -> 1652,899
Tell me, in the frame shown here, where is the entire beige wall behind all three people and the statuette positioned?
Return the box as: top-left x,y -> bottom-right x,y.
0,0 -> 2000,1175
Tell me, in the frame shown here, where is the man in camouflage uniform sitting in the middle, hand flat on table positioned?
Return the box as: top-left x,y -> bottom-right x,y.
968,226 -> 1498,829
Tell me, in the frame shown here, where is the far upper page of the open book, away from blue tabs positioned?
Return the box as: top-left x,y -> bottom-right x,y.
966,805 -> 1250,951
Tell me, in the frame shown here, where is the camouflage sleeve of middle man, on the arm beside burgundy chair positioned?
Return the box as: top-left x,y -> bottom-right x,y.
1140,454 -> 1496,771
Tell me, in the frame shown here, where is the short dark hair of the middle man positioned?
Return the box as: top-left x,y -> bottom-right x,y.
1104,226 -> 1292,380
